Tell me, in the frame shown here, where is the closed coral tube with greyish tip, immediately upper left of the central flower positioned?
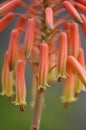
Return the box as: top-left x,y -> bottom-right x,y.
24,18 -> 36,58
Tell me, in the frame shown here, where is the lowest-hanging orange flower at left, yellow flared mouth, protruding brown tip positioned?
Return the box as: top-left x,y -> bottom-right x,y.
15,60 -> 26,112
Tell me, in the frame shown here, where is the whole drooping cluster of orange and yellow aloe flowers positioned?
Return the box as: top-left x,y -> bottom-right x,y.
0,0 -> 86,130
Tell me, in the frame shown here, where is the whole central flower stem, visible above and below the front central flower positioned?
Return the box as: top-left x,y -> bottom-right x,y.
30,0 -> 48,130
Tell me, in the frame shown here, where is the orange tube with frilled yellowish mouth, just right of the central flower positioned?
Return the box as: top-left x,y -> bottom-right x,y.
57,32 -> 68,81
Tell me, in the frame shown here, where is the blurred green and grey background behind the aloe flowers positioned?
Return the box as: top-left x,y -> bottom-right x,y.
0,0 -> 86,130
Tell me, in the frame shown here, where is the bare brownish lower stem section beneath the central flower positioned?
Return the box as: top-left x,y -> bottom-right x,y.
30,90 -> 44,130
